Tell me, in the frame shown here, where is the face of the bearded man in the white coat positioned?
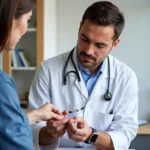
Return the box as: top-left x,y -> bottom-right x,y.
77,20 -> 119,73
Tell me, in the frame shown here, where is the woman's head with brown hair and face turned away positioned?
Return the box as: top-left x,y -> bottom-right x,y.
0,0 -> 35,51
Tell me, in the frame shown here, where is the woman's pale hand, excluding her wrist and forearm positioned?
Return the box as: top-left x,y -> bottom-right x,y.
37,102 -> 64,121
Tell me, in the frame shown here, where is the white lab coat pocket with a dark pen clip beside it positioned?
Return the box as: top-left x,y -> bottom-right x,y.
98,112 -> 114,131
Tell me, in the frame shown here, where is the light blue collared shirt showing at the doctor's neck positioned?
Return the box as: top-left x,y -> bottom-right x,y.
77,58 -> 105,96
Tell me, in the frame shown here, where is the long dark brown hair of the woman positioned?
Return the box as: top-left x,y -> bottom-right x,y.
0,0 -> 35,51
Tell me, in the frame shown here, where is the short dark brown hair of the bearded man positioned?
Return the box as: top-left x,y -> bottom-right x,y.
82,1 -> 125,41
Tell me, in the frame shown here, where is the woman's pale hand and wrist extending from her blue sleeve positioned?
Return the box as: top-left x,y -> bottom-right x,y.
26,102 -> 64,124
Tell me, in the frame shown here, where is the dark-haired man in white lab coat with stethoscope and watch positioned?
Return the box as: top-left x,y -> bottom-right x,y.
29,1 -> 138,150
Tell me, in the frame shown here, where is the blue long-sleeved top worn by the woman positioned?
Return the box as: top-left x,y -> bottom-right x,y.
0,70 -> 35,150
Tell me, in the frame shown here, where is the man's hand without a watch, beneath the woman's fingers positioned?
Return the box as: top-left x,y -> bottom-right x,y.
46,111 -> 68,138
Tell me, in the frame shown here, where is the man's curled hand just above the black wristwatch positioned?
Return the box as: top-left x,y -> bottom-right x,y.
67,117 -> 92,142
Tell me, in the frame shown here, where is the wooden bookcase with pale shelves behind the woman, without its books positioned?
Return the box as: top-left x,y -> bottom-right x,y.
3,0 -> 44,108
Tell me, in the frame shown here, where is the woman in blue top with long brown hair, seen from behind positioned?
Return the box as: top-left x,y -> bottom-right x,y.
0,0 -> 63,150
